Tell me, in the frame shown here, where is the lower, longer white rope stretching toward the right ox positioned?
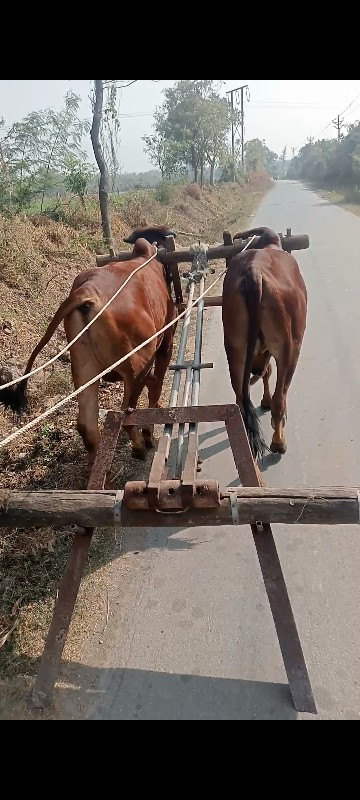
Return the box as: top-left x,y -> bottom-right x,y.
0,265 -> 226,449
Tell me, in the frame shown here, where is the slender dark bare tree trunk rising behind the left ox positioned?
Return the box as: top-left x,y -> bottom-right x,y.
91,81 -> 114,252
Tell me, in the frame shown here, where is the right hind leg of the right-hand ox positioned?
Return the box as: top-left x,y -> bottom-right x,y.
270,344 -> 300,455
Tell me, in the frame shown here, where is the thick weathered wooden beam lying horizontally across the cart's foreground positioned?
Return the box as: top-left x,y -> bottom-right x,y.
0,488 -> 359,535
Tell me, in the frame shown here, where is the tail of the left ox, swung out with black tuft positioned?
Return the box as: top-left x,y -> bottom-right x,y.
0,287 -> 94,414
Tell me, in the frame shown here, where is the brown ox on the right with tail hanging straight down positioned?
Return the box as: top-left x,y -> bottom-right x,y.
223,228 -> 307,458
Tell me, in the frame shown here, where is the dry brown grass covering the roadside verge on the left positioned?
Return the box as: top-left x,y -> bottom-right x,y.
0,175 -> 267,718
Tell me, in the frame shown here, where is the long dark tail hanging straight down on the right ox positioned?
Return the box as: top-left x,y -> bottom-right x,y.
242,268 -> 268,460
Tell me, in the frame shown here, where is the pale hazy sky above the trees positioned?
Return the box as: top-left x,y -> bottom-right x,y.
0,80 -> 360,172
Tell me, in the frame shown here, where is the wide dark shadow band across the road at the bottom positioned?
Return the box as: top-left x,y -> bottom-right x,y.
55,663 -> 297,720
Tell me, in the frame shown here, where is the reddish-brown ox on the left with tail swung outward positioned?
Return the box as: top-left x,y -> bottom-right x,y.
0,229 -> 175,463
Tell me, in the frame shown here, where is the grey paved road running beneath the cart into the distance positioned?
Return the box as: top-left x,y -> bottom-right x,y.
57,182 -> 360,720
